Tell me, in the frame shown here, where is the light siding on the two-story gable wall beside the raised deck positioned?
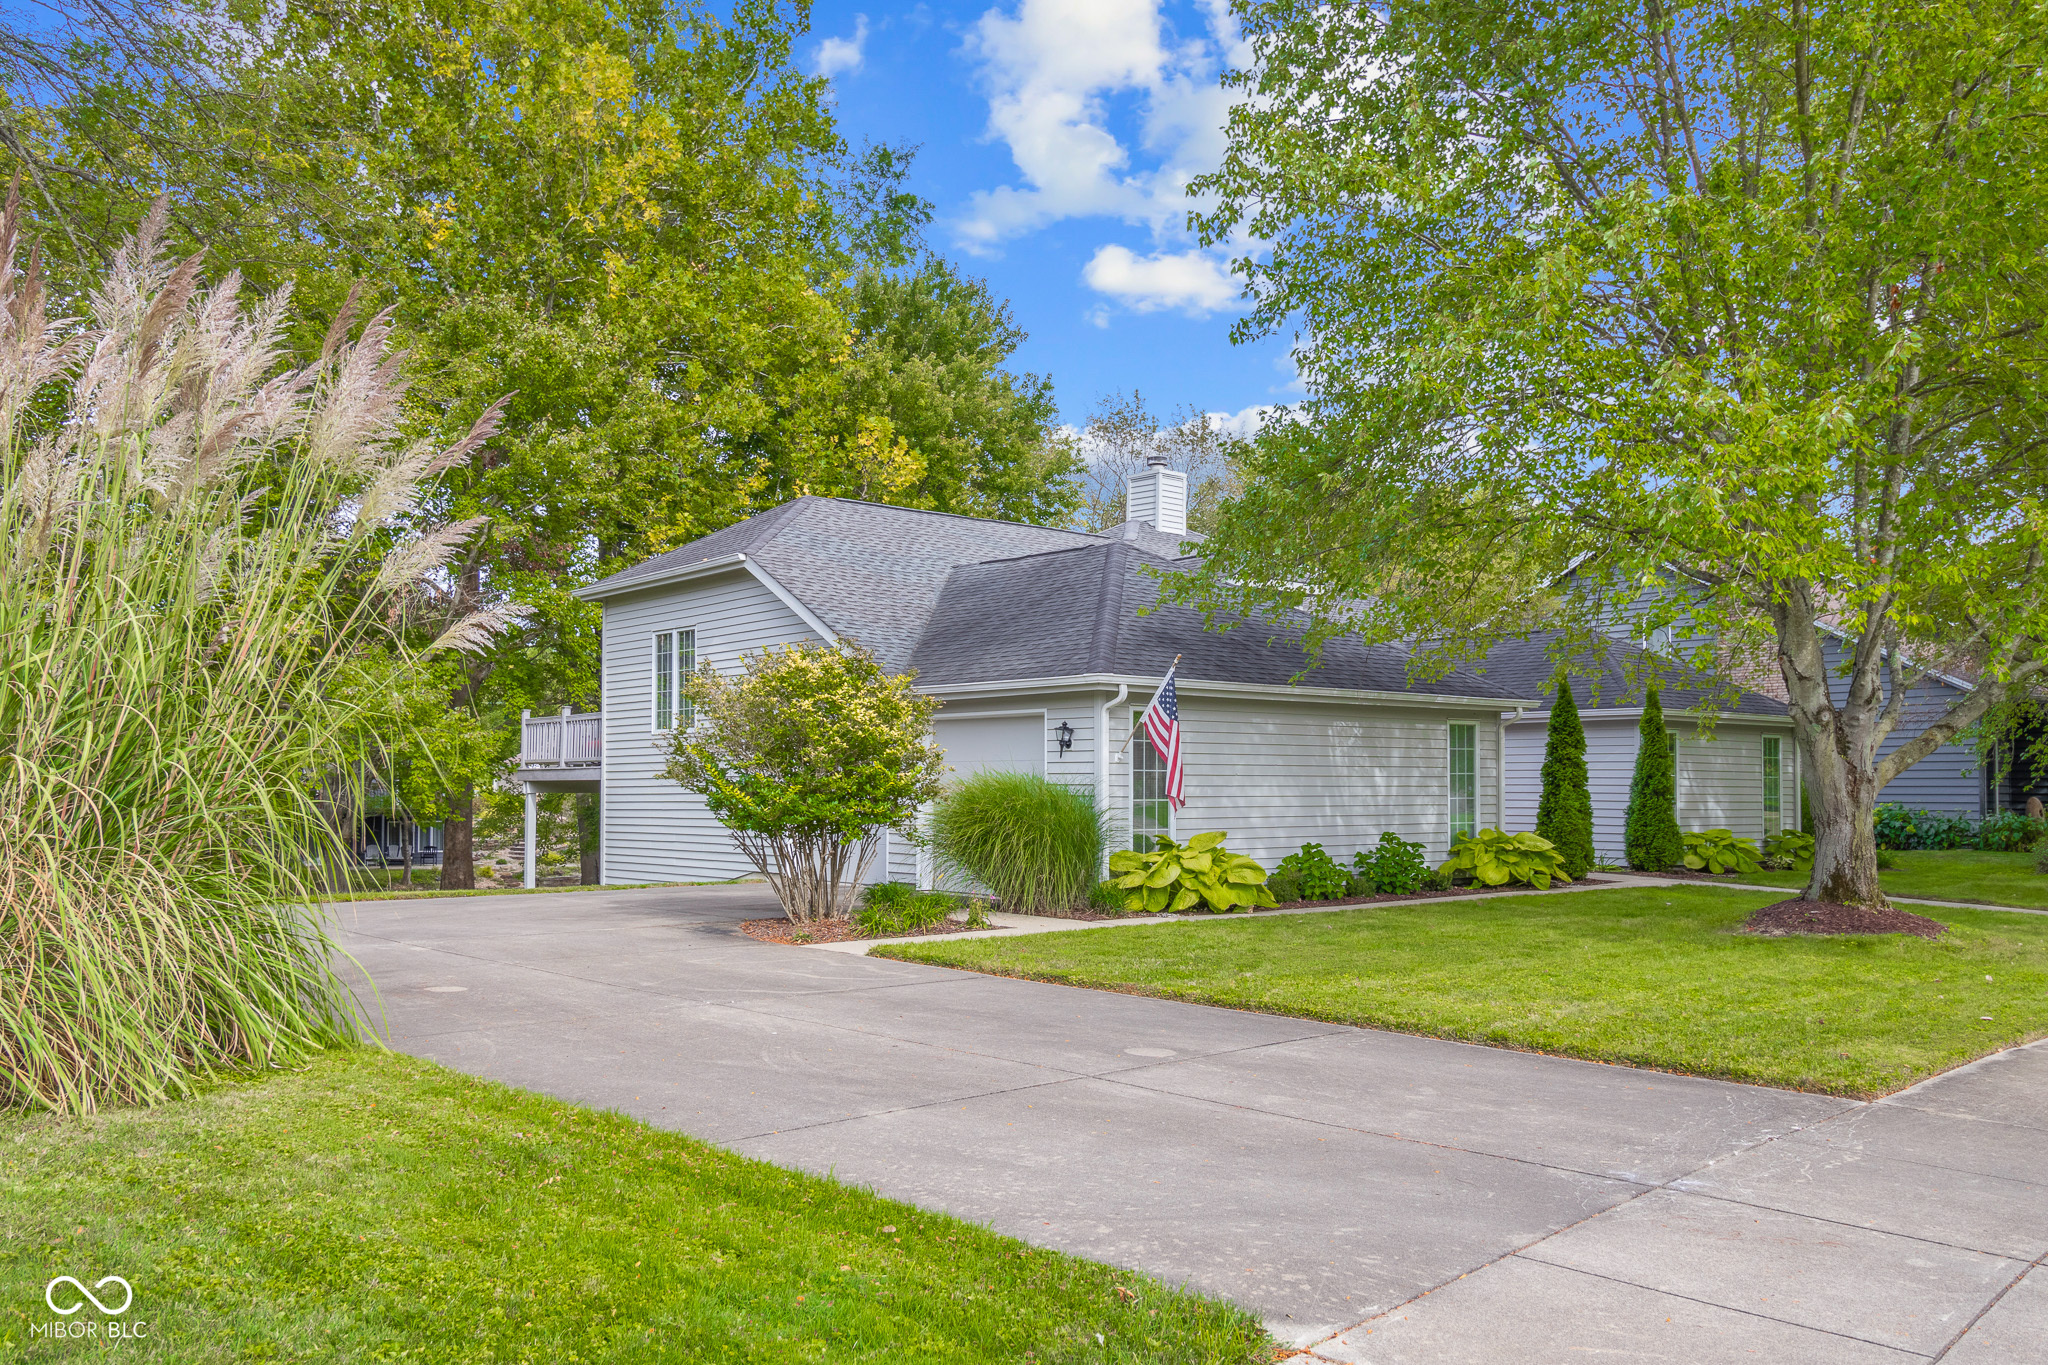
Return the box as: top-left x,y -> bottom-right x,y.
600,569 -> 819,884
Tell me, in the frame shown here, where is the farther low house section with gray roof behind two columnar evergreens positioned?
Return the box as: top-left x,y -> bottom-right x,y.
1477,632 -> 1798,864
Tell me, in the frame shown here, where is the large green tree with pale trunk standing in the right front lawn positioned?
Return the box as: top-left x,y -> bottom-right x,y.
1180,0 -> 2048,905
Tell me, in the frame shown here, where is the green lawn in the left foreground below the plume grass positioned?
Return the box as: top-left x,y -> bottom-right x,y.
0,1052 -> 1272,1365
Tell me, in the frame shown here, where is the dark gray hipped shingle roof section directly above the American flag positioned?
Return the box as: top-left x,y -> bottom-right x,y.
911,540 -> 1534,700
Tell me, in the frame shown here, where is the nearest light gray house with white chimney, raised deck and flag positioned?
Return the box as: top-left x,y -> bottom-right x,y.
516,467 -> 1536,884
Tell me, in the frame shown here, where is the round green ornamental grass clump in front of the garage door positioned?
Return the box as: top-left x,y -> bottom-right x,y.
932,772 -> 1114,915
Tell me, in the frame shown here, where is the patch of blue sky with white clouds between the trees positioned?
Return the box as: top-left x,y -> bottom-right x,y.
799,0 -> 1298,426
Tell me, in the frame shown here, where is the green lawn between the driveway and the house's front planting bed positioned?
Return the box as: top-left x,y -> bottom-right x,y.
877,882 -> 2048,1097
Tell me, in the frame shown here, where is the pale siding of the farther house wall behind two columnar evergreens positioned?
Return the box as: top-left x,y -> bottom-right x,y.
1507,712 -> 1798,864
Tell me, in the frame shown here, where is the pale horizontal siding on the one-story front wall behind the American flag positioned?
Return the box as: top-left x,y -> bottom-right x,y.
1110,692 -> 1499,868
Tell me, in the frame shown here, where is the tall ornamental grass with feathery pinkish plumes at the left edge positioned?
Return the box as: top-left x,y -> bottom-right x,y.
0,194 -> 509,1113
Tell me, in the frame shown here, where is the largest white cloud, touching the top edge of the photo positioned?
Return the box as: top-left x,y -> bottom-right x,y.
954,0 -> 1245,252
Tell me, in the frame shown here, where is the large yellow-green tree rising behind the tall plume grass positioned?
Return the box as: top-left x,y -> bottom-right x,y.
0,0 -> 1073,886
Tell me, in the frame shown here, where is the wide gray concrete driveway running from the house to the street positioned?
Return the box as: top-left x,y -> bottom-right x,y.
338,886 -> 2048,1365
